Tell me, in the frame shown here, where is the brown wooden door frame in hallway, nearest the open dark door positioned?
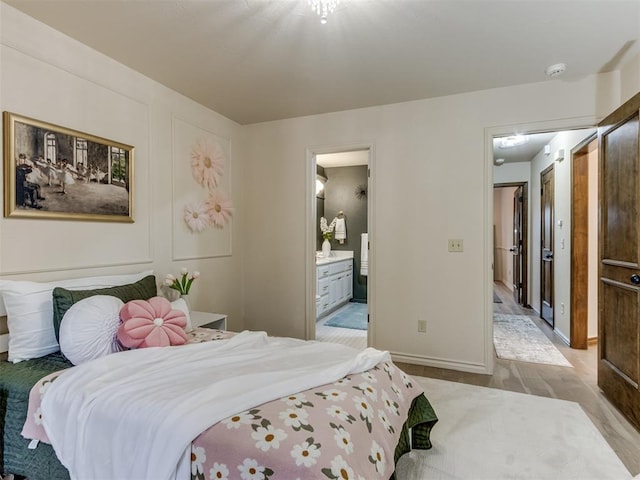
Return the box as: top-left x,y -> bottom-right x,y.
569,131 -> 598,350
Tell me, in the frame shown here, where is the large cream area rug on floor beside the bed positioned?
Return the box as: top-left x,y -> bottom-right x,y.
397,376 -> 633,480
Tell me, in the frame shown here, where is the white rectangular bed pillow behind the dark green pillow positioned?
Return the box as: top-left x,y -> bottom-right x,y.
0,270 -> 153,363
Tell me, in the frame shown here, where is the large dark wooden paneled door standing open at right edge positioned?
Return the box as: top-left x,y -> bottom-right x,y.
598,94 -> 640,428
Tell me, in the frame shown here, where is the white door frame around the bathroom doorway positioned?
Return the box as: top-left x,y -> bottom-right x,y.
304,142 -> 377,346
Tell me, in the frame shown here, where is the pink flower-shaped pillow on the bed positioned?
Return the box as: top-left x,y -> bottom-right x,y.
118,297 -> 187,348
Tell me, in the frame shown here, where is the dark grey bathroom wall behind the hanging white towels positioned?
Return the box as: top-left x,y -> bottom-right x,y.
318,165 -> 368,302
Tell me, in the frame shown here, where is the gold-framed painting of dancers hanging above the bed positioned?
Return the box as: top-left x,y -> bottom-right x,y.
3,112 -> 133,223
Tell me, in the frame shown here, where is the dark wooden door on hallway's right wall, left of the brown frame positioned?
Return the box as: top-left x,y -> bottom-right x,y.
540,164 -> 554,327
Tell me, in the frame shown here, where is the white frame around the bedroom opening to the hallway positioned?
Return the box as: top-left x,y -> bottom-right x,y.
483,115 -> 599,375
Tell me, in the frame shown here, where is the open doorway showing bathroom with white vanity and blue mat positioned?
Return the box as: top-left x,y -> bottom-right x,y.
314,148 -> 370,349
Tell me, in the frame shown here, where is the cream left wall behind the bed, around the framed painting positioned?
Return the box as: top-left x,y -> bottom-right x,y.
0,3 -> 243,328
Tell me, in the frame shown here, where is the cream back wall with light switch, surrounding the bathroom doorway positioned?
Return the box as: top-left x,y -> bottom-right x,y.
244,77 -> 619,371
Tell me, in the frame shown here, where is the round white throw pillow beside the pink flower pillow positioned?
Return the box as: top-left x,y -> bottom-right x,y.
60,295 -> 124,365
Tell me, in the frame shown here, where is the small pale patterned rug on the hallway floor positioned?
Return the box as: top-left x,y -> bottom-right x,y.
493,313 -> 572,367
